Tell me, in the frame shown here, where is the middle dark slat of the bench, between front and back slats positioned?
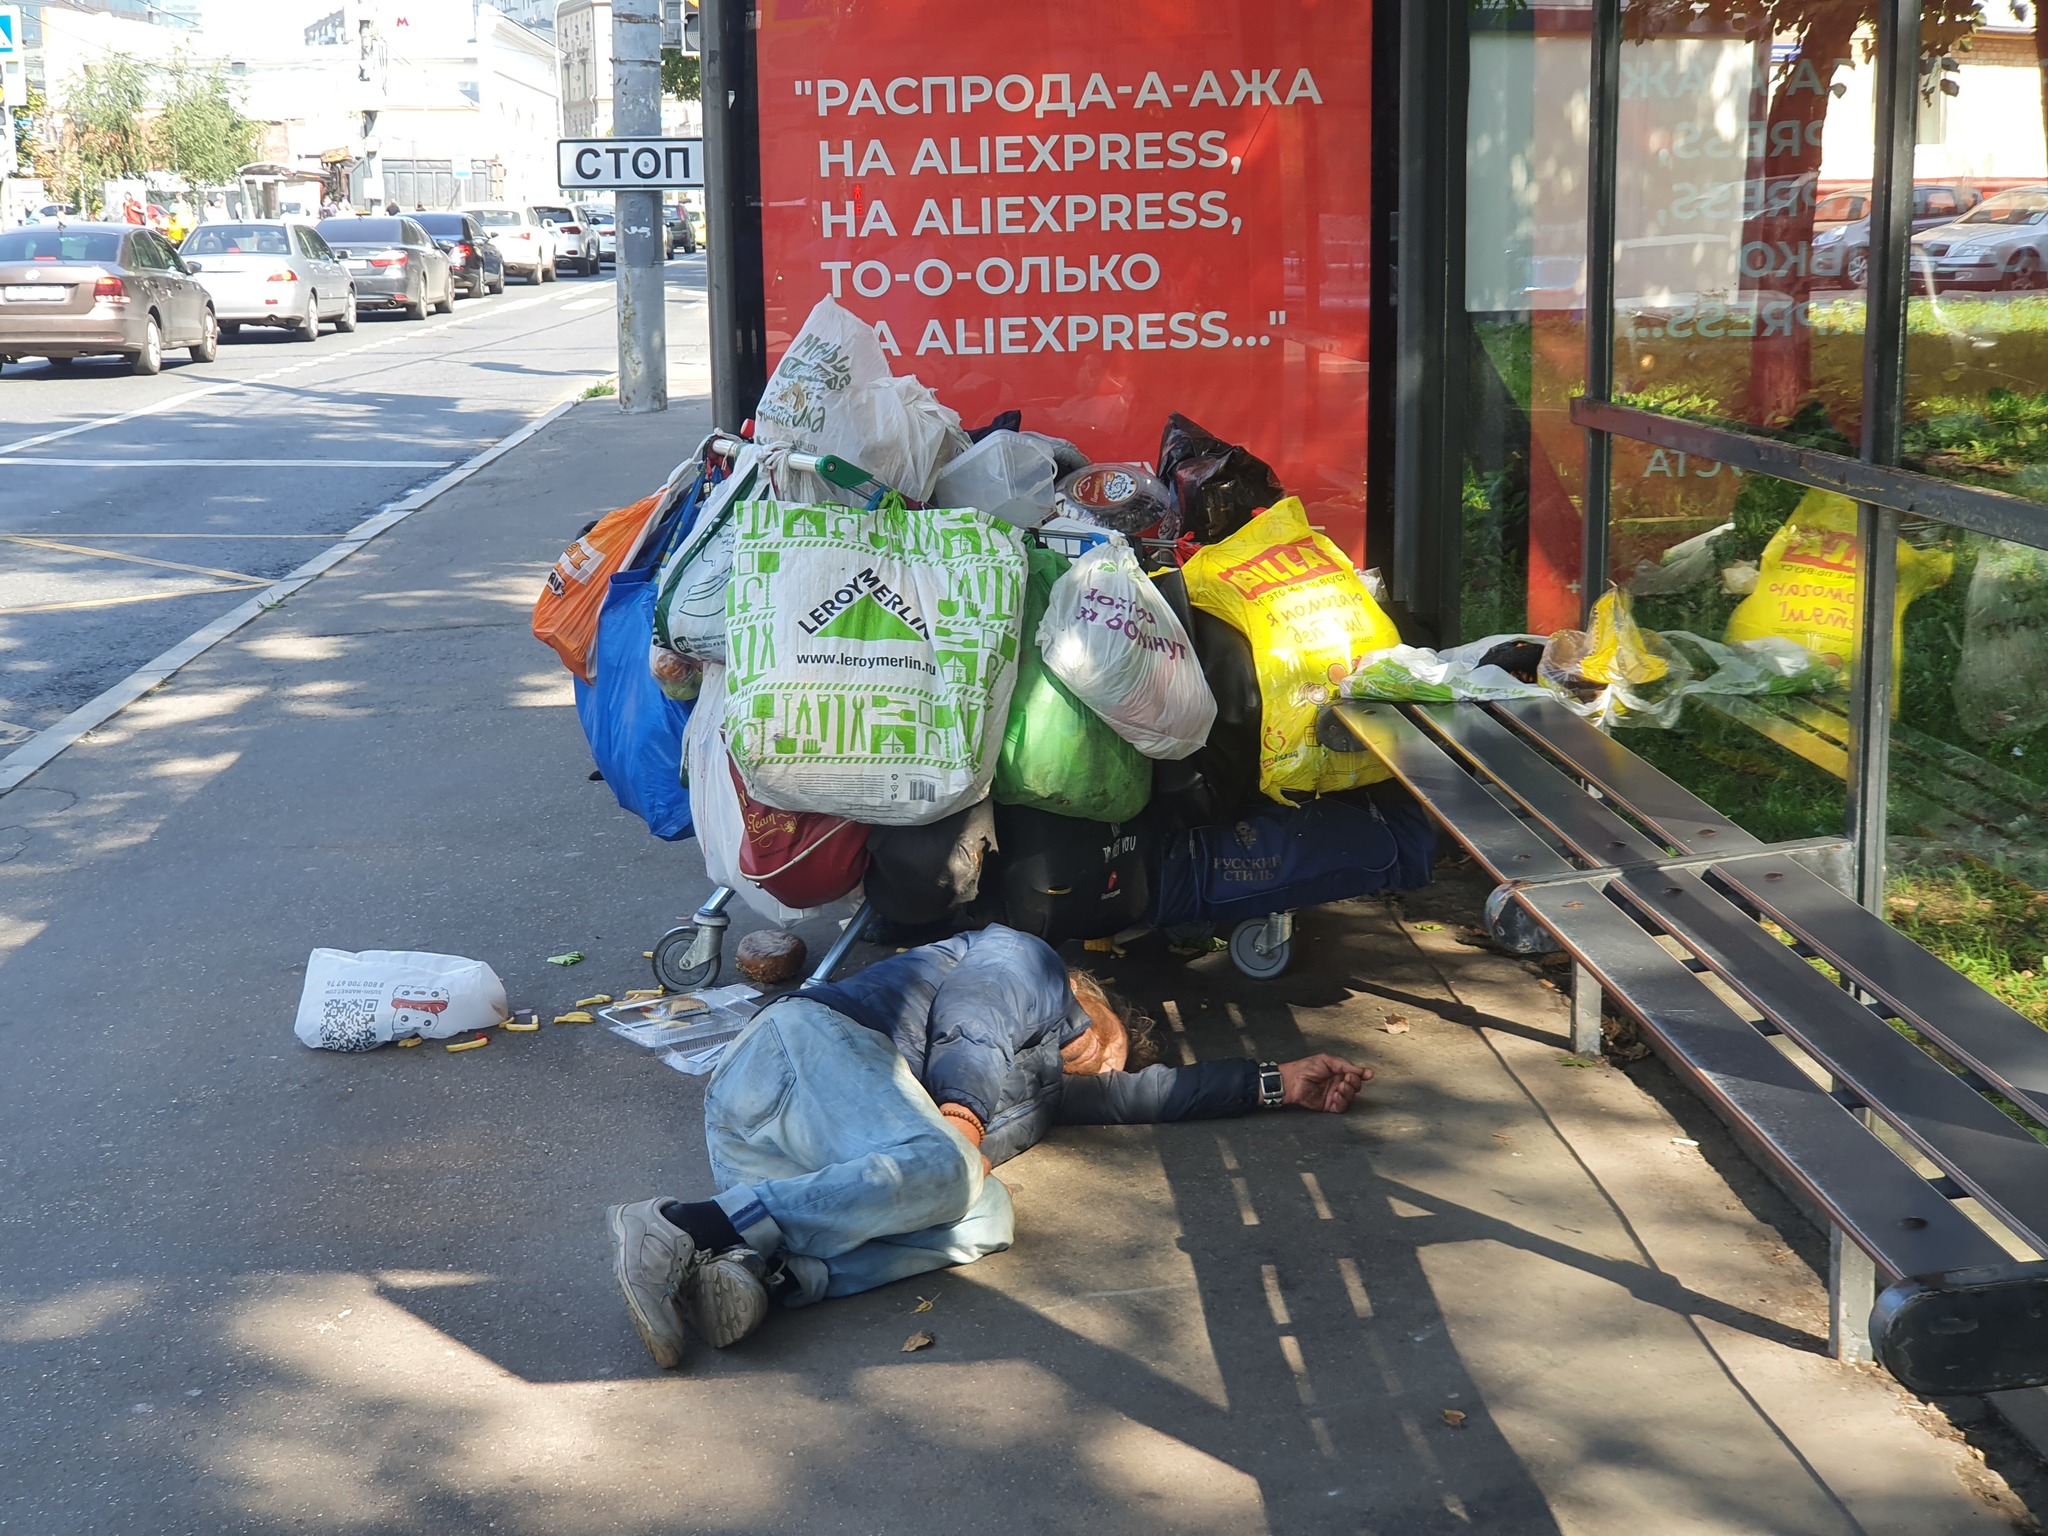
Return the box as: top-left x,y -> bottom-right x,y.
1417,705 -> 2048,1253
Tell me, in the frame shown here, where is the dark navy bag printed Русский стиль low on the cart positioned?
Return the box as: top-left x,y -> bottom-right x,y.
1153,791 -> 1436,928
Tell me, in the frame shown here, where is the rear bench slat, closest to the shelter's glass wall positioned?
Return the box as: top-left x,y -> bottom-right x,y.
1499,700 -> 2048,1124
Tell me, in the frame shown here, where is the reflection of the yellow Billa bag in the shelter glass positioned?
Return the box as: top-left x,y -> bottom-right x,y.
1726,492 -> 1956,696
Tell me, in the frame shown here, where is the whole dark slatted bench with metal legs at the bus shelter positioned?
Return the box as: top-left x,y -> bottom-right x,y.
1325,700 -> 2048,1393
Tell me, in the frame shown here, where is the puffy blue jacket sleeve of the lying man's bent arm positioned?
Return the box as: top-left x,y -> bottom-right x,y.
924,928 -> 1073,1124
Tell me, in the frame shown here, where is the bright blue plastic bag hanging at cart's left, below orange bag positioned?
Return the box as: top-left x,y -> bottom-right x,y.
575,565 -> 690,842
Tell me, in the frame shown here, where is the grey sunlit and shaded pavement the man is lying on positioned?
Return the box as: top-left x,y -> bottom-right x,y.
0,401 -> 2030,1536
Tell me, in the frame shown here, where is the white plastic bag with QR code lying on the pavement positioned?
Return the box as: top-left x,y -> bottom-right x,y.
293,950 -> 512,1051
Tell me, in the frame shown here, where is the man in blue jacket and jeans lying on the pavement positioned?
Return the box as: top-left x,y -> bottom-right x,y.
610,928 -> 1372,1368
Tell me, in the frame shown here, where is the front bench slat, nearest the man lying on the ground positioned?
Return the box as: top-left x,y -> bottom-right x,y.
1335,702 -> 2005,1276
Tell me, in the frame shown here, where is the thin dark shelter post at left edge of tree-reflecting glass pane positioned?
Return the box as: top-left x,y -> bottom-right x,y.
1579,0 -> 1622,623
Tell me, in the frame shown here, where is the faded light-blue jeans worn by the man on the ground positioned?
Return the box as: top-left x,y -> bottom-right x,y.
705,997 -> 1014,1307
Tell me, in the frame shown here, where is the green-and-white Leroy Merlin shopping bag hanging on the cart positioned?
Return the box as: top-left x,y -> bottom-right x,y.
725,496 -> 1024,827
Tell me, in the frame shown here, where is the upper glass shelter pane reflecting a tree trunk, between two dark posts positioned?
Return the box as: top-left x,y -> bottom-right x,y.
1614,0 -> 1874,450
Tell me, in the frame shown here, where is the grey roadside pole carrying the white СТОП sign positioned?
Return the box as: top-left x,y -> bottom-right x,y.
612,0 -> 668,416
